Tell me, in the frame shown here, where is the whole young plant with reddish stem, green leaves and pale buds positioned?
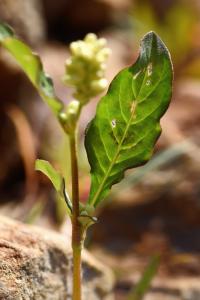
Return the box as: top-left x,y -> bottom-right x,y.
0,24 -> 173,300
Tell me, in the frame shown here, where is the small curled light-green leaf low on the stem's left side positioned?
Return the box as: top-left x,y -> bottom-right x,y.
35,159 -> 63,192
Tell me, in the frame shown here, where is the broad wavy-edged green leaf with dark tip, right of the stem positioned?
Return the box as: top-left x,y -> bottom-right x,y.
85,32 -> 173,206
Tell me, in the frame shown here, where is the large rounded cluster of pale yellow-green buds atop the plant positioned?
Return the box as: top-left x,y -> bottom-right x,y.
64,33 -> 111,104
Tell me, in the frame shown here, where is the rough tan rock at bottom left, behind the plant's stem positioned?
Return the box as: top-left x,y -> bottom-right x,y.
0,216 -> 113,300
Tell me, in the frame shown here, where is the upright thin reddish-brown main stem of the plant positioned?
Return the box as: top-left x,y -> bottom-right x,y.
69,131 -> 82,300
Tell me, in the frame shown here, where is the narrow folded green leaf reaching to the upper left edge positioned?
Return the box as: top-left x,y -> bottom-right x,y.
0,23 -> 63,115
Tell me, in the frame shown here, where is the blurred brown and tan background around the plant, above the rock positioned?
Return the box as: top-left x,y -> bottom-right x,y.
0,0 -> 200,300
